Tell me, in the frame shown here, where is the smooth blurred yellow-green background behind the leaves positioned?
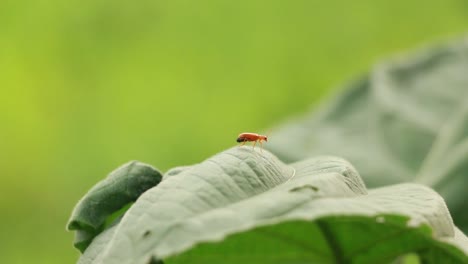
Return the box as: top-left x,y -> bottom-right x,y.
0,0 -> 468,264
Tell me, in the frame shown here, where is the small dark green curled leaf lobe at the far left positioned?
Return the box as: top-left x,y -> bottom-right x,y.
67,161 -> 162,252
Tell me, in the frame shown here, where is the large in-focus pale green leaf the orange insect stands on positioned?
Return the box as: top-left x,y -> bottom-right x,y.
73,150 -> 468,264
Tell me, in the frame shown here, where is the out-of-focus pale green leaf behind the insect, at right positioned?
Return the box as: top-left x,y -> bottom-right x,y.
267,38 -> 468,231
